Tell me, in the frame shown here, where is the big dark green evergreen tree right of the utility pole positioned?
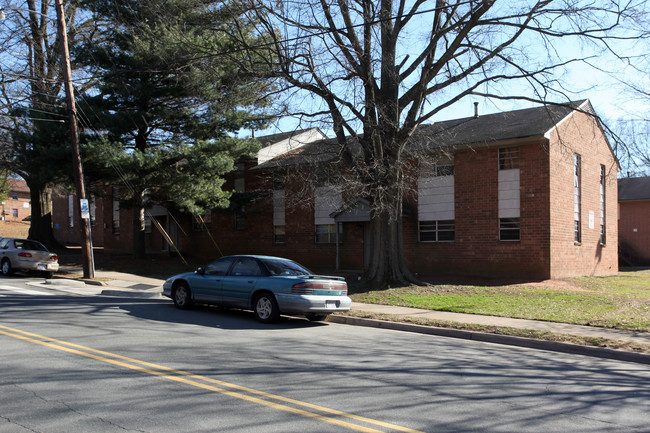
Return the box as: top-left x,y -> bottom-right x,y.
75,0 -> 271,257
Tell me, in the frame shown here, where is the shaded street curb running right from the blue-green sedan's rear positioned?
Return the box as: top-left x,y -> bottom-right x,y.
327,314 -> 650,364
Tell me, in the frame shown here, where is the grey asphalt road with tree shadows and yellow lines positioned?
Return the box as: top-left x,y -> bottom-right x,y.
0,277 -> 650,433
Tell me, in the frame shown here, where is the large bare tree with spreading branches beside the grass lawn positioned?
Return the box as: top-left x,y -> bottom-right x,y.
233,0 -> 645,286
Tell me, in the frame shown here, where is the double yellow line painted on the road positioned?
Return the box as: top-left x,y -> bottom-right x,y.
0,325 -> 422,433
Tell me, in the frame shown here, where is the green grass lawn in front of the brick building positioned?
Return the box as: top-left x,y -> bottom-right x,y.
350,270 -> 650,331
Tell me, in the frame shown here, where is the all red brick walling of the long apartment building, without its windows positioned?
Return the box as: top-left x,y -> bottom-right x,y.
82,109 -> 618,278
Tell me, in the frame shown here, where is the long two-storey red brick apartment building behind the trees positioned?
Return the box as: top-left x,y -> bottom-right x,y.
53,100 -> 618,278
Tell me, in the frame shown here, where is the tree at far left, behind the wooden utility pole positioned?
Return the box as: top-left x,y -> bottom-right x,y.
0,0 -> 92,246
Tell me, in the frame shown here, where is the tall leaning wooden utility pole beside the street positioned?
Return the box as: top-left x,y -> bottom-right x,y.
55,0 -> 95,278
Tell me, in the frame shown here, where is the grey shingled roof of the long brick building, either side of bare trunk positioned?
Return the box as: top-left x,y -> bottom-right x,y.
256,99 -> 593,169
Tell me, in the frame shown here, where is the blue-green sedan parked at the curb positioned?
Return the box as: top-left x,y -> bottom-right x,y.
163,255 -> 352,323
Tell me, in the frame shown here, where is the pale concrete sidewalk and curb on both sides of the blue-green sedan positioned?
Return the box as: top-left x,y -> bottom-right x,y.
57,268 -> 650,364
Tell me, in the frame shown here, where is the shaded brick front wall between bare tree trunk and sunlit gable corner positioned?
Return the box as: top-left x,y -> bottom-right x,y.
404,143 -> 550,278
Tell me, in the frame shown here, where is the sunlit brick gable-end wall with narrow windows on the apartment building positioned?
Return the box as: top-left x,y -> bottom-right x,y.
550,112 -> 618,278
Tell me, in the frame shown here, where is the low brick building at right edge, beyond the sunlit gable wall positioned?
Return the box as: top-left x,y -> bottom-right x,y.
618,177 -> 650,266
